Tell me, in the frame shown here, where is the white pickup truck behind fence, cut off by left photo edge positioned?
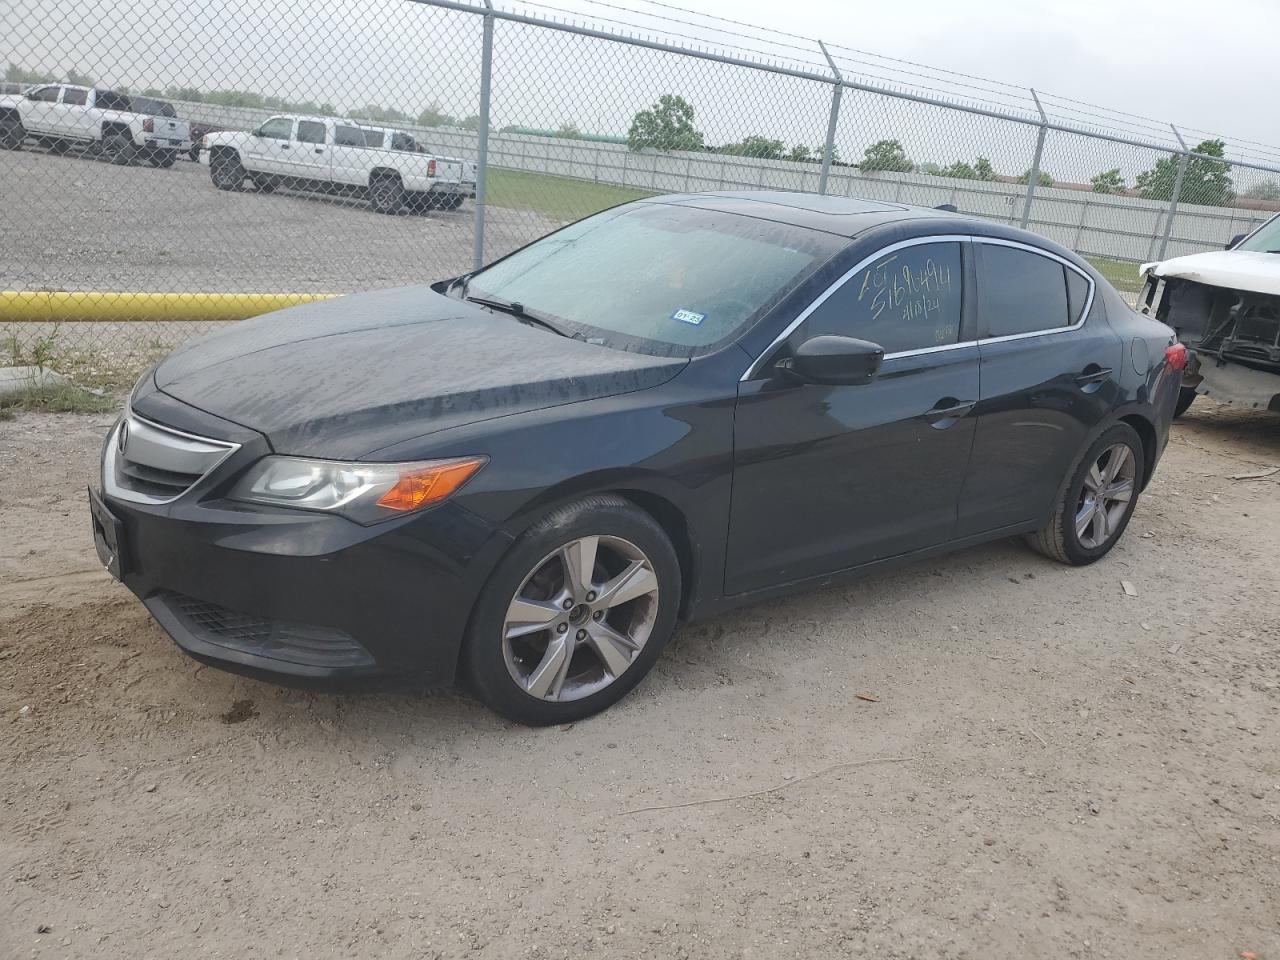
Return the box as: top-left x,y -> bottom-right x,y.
0,83 -> 191,166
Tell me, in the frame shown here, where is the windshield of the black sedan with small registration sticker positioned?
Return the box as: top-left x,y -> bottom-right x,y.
466,204 -> 844,356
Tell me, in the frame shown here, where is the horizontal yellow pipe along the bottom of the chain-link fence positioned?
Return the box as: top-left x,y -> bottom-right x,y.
0,291 -> 340,324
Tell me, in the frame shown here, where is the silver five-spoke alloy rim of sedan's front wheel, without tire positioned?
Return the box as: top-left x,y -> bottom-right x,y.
502,536 -> 658,701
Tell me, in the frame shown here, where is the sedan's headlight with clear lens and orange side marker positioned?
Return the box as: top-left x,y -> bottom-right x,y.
230,457 -> 488,524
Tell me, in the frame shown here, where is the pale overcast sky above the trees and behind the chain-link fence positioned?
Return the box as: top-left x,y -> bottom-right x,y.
0,0 -> 1280,180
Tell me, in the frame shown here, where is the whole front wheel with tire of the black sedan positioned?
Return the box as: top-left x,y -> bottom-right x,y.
462,494 -> 681,726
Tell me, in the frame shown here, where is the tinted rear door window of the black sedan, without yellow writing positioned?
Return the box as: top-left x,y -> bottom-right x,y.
975,243 -> 1084,337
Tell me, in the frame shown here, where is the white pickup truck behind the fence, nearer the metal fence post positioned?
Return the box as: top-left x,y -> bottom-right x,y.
200,115 -> 462,214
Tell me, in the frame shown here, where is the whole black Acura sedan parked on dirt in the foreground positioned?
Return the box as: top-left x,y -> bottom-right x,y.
91,192 -> 1187,723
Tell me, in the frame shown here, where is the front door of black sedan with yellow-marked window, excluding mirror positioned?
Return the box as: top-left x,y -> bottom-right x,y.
726,238 -> 978,594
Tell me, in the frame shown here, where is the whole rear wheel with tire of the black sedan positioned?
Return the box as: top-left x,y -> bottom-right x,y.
1027,424 -> 1144,567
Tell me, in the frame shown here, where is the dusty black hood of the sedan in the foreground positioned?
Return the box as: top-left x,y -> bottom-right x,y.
155,287 -> 687,460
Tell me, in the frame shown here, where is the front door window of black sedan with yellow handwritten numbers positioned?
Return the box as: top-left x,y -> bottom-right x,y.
806,241 -> 964,353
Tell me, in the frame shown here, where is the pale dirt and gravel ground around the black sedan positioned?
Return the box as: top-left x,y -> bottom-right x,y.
0,401 -> 1280,960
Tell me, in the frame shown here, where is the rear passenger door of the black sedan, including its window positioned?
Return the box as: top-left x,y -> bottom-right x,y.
957,237 -> 1123,536
